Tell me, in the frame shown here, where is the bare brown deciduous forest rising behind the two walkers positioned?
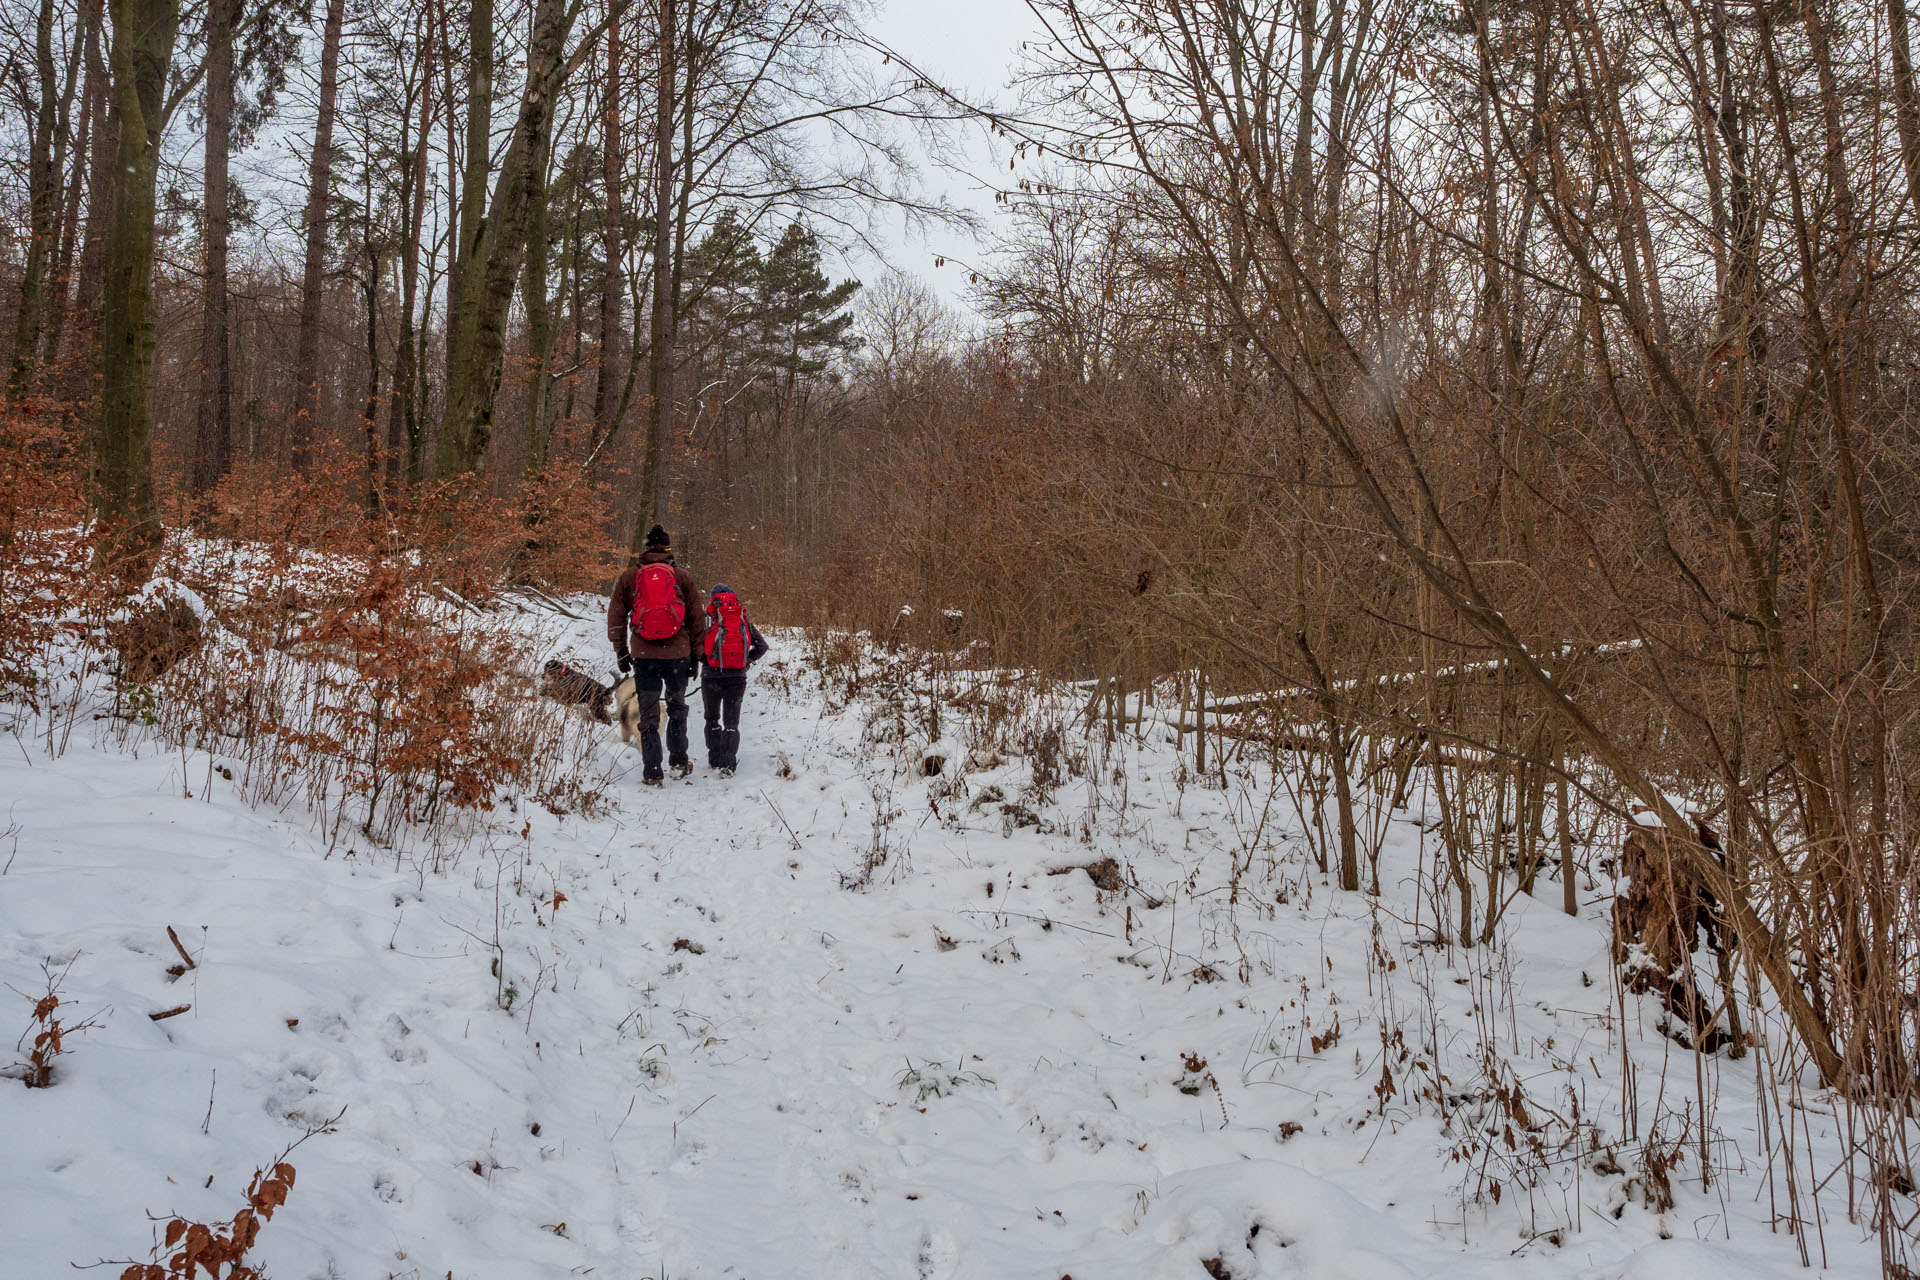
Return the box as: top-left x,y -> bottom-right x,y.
11,0 -> 1920,1276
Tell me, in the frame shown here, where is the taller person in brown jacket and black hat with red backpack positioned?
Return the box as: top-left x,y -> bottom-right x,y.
607,524 -> 707,787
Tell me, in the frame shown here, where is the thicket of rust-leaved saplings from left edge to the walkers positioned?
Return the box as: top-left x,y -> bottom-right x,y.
0,415 -> 609,867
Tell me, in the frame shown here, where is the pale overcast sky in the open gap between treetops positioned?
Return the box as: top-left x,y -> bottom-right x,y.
849,0 -> 1039,307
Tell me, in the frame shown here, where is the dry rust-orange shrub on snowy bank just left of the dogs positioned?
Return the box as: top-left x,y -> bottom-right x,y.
140,545 -> 597,841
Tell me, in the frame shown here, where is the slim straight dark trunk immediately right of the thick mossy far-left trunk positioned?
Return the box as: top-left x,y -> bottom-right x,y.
194,0 -> 236,497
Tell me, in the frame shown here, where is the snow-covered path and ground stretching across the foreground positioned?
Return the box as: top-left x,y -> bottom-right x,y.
0,594 -> 1878,1280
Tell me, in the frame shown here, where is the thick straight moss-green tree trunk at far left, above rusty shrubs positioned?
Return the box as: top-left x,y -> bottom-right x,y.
90,0 -> 180,583
